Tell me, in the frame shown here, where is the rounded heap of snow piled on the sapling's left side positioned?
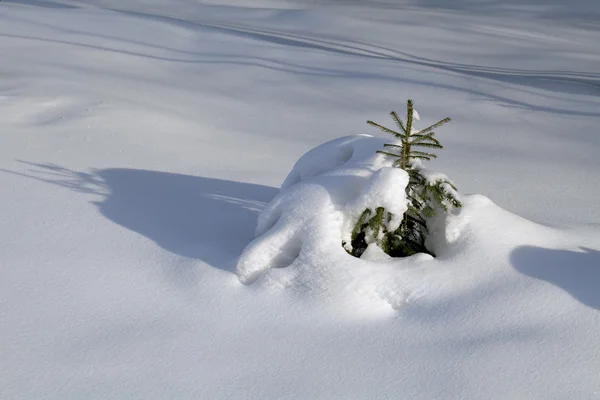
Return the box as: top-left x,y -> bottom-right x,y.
237,135 -> 420,291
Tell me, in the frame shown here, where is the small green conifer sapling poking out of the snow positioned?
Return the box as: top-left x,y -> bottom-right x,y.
349,100 -> 462,257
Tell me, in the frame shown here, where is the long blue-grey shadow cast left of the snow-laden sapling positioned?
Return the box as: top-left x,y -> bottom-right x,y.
5,163 -> 278,272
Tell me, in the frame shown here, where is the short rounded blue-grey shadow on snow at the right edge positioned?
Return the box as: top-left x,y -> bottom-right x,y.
510,246 -> 600,310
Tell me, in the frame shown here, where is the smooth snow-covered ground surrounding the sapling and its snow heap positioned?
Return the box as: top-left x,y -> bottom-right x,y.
0,0 -> 600,399
